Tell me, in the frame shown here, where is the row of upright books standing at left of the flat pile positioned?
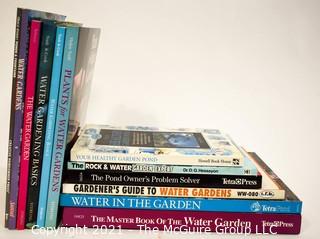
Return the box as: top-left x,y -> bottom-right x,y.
5,8 -> 100,229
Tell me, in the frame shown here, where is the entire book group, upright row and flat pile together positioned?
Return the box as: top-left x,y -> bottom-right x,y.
5,8 -> 302,234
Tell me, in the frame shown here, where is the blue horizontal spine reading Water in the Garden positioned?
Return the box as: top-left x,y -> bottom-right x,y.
60,194 -> 302,214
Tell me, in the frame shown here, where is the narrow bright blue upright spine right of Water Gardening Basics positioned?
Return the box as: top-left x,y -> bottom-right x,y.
37,26 -> 65,227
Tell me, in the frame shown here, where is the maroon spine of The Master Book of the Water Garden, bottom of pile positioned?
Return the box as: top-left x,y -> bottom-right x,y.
62,207 -> 301,236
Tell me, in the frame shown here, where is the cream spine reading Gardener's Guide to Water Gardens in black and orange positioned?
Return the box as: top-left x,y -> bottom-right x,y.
62,183 -> 285,200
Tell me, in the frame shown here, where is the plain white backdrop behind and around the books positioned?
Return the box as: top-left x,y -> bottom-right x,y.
0,0 -> 320,238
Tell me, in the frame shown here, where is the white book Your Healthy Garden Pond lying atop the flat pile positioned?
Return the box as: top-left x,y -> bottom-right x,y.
71,125 -> 244,167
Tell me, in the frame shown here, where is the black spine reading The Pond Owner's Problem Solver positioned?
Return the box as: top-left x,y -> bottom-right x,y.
64,170 -> 262,189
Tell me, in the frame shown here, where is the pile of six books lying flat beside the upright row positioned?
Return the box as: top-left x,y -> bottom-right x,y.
60,125 -> 302,234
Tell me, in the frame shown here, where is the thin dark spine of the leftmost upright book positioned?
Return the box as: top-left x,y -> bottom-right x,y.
5,8 -> 22,229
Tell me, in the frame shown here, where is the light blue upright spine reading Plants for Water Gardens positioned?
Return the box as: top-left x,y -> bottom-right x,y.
45,26 -> 79,227
